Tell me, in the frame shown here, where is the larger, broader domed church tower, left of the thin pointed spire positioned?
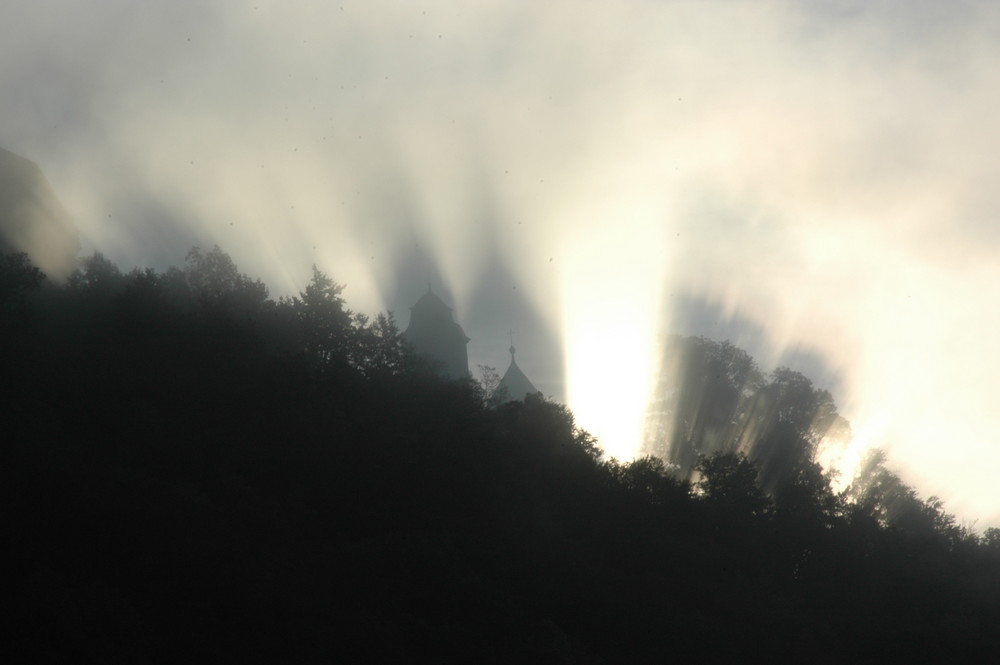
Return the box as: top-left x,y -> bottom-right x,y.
403,283 -> 469,379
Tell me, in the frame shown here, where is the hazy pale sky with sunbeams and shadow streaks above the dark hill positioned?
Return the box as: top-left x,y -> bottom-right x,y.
0,0 -> 1000,528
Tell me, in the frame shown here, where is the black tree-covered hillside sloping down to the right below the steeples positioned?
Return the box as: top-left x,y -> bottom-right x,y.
0,247 -> 1000,663
